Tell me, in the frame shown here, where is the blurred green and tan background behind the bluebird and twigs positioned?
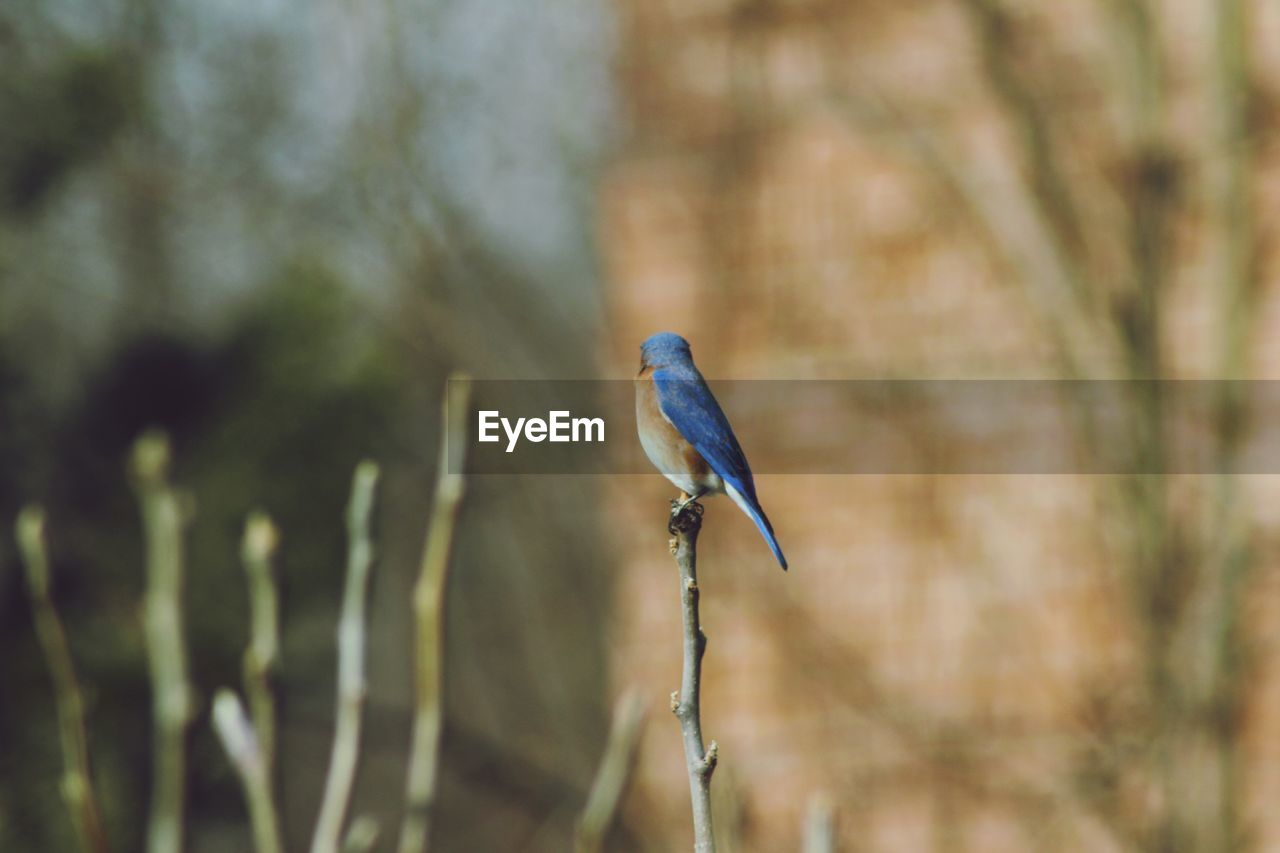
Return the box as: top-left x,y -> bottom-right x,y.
0,0 -> 1280,850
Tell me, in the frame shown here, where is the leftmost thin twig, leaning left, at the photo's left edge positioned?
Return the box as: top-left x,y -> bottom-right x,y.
17,506 -> 106,853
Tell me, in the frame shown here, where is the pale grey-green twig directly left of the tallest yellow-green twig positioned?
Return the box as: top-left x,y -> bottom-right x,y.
311,460 -> 378,853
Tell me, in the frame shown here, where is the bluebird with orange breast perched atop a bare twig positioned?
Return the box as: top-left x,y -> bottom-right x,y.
636,332 -> 787,570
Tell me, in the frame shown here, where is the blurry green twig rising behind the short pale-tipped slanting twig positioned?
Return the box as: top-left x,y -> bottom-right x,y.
241,512 -> 280,783
